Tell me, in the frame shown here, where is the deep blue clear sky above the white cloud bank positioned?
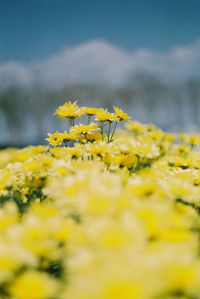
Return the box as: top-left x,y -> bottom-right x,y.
0,0 -> 200,62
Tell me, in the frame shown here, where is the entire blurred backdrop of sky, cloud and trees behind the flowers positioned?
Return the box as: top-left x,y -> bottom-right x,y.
0,0 -> 200,147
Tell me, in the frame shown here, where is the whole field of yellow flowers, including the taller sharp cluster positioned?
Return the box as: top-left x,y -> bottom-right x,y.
0,102 -> 200,299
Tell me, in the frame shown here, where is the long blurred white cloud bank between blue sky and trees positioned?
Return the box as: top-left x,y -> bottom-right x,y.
0,40 -> 200,87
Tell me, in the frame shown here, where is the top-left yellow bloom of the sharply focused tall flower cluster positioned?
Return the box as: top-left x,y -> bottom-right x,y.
55,101 -> 84,119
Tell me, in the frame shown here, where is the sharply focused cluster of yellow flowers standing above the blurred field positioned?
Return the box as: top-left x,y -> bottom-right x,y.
47,102 -> 130,146
